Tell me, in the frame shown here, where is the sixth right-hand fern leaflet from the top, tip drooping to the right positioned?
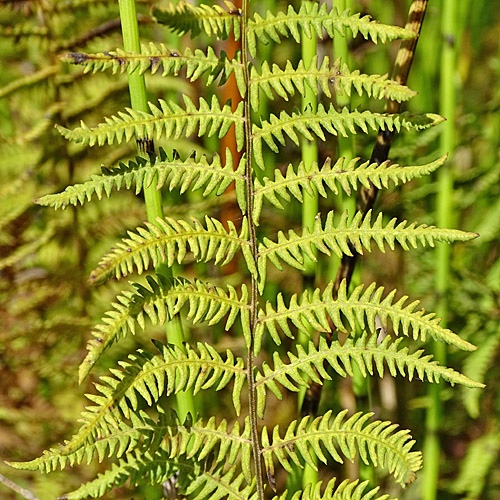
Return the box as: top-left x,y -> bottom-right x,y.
255,280 -> 476,351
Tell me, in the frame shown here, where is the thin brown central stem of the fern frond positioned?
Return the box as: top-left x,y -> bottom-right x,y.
241,0 -> 264,500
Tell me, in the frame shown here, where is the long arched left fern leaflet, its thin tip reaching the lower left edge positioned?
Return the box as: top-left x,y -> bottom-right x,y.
9,341 -> 247,469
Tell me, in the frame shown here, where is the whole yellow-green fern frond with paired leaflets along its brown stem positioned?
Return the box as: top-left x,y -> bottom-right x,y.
11,0 -> 482,500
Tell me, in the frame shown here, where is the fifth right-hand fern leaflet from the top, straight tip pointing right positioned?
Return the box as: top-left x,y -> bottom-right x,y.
258,210 -> 478,291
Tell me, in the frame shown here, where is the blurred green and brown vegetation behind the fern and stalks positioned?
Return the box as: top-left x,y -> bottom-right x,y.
0,0 -> 500,500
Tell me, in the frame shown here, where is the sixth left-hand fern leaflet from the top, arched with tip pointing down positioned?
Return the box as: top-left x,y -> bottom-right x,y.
79,276 -> 250,383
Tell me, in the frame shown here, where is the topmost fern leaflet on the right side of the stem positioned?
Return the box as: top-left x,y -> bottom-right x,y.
247,3 -> 415,57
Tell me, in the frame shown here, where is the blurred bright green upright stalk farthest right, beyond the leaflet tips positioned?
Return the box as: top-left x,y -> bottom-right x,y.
422,0 -> 457,500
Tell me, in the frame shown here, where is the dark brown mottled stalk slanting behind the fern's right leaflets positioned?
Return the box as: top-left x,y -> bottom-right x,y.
300,0 -> 428,418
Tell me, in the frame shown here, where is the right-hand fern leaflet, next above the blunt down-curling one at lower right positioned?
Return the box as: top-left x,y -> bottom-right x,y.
256,333 -> 484,417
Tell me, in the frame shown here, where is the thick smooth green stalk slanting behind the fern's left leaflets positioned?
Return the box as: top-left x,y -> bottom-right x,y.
118,0 -> 195,422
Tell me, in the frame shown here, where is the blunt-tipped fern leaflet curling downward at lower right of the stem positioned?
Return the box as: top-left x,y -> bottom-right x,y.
262,410 -> 422,486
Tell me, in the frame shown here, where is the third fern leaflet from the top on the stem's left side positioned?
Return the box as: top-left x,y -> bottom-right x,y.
57,95 -> 244,147
